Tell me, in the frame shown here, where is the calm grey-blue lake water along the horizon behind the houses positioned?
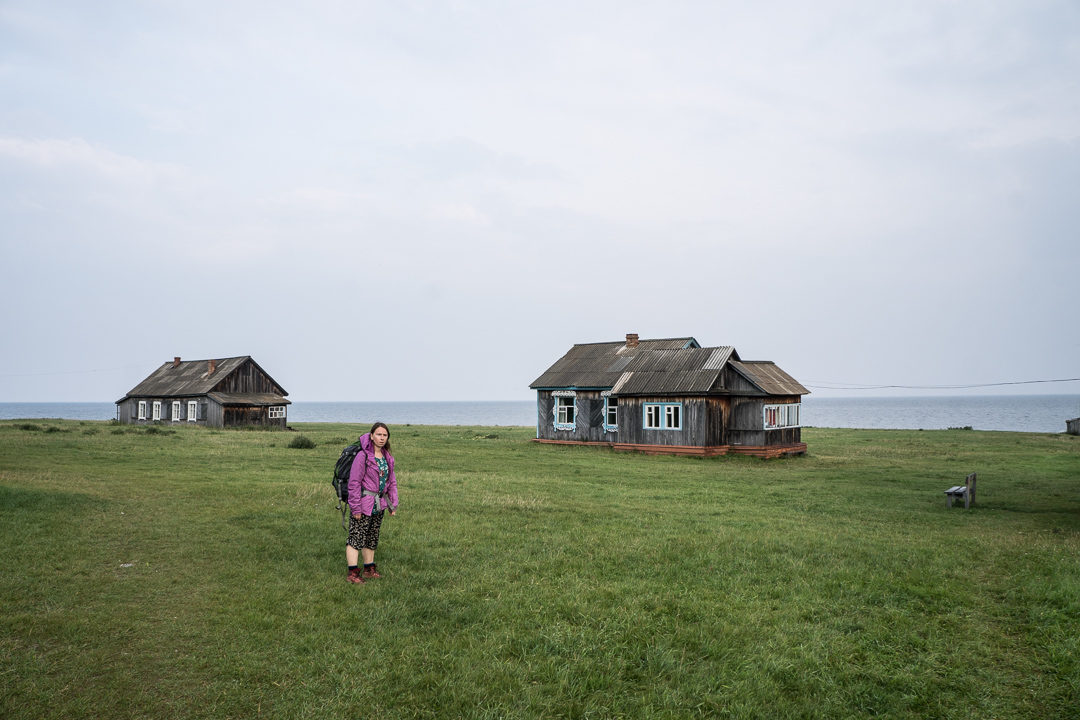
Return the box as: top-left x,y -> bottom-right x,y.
0,395 -> 1080,433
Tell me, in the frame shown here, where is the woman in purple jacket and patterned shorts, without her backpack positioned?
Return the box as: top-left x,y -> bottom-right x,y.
345,422 -> 397,584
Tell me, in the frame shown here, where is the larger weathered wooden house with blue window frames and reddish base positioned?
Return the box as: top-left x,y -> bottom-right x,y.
529,335 -> 810,458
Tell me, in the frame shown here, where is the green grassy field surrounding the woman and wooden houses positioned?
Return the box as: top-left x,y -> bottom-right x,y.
0,421 -> 1080,720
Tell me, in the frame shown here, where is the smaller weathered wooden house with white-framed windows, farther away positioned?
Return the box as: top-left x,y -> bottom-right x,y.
117,355 -> 289,429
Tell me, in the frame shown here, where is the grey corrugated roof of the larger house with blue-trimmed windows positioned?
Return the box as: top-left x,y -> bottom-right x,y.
529,338 -> 810,395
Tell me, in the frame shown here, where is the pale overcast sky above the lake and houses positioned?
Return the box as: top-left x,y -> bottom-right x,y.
0,0 -> 1080,402
